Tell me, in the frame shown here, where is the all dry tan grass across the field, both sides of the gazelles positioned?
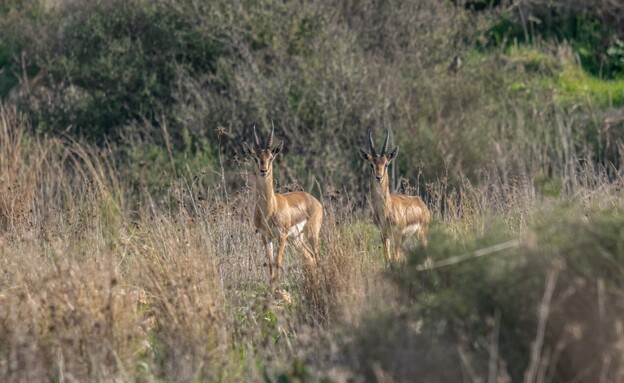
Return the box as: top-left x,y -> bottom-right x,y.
0,103 -> 623,381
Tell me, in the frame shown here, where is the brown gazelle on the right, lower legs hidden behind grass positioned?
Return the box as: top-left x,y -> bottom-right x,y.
359,130 -> 431,262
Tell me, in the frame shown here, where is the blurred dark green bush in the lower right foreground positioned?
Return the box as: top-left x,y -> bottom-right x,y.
351,207 -> 624,382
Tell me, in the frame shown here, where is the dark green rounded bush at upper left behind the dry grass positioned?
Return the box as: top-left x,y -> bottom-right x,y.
29,0 -> 226,142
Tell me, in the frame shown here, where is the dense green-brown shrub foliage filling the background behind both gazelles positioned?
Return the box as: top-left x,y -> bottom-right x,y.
0,0 -> 624,204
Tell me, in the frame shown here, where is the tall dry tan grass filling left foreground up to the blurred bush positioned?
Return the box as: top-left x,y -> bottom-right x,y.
0,103 -> 386,381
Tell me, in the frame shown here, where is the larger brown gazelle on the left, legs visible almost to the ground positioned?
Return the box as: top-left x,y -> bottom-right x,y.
243,125 -> 323,286
